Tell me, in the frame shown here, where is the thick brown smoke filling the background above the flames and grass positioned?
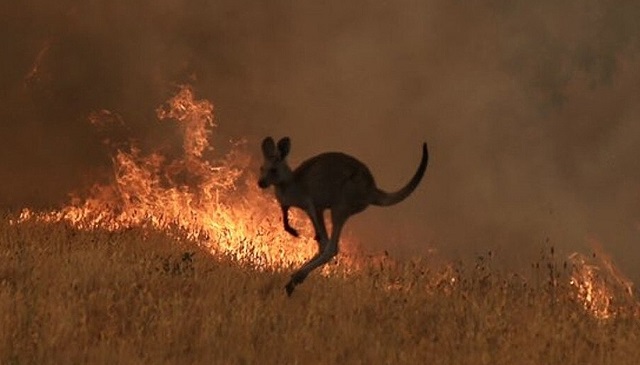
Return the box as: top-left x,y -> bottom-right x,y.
0,0 -> 640,279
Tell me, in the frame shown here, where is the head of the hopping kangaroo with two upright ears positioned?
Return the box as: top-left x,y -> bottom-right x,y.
258,137 -> 291,189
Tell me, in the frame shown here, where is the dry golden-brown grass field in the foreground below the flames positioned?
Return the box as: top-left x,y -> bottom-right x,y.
0,219 -> 640,365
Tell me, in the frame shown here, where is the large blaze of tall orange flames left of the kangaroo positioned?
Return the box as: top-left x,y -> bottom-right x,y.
19,86 -> 360,269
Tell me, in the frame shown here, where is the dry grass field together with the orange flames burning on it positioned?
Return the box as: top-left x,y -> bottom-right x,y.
6,87 -> 640,365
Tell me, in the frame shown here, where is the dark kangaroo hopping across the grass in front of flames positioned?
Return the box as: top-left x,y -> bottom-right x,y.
258,137 -> 429,296
